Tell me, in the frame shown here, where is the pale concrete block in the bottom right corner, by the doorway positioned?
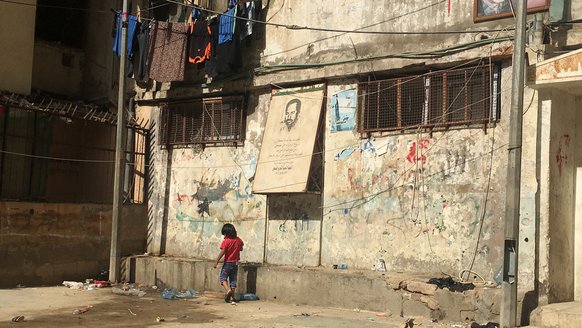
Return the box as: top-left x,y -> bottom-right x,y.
531,302 -> 582,328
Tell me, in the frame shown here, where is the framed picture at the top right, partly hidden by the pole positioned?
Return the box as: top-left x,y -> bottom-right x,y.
473,0 -> 550,22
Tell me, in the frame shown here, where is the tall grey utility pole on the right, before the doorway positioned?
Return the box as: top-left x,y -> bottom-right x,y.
501,0 -> 527,328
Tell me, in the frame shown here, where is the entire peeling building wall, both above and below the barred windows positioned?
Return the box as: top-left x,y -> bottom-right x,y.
140,0 -> 539,290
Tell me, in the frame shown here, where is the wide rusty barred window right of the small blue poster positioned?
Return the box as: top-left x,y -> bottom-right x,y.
358,65 -> 501,133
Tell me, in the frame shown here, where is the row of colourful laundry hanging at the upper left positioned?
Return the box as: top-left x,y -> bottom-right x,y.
113,0 -> 261,82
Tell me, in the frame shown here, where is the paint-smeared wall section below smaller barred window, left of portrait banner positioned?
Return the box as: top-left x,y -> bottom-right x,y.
161,103 -> 268,262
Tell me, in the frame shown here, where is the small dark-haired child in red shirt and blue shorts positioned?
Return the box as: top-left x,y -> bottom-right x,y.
214,223 -> 244,303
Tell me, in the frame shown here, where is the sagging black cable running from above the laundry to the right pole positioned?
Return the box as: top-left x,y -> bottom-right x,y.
166,0 -> 516,35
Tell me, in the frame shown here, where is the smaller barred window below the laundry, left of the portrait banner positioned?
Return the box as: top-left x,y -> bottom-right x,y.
159,97 -> 244,146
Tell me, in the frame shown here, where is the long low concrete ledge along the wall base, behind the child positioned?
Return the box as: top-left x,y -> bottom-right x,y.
122,256 -> 502,327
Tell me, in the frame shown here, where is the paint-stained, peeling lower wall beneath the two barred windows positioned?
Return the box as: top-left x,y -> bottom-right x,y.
144,66 -> 537,291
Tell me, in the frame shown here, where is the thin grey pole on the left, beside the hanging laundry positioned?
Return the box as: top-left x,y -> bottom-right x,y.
109,0 -> 128,282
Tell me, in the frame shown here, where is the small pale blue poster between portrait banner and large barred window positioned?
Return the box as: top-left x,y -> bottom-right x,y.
331,89 -> 357,132
